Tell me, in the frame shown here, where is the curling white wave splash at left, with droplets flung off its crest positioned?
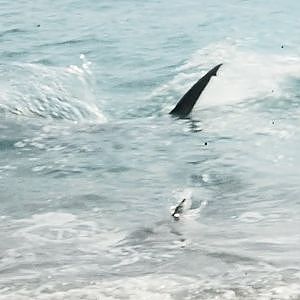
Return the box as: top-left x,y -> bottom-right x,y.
0,55 -> 105,122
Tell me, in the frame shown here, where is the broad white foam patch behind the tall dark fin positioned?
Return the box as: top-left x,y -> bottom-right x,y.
151,42 -> 300,108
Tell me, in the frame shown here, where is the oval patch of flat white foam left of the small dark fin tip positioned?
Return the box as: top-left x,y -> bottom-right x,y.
13,211 -> 125,252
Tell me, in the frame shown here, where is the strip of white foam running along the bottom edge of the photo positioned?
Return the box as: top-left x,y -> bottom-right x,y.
0,274 -> 300,300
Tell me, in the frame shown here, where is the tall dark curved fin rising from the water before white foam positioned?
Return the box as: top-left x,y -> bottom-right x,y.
170,64 -> 222,118
